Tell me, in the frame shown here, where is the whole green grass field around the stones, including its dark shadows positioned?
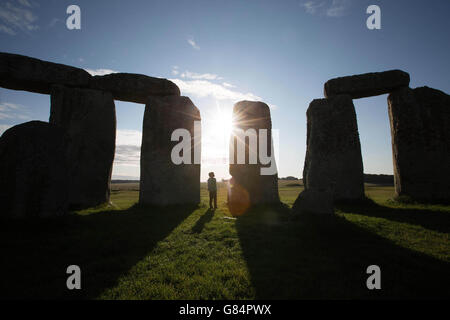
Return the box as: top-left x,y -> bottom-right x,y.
0,181 -> 450,299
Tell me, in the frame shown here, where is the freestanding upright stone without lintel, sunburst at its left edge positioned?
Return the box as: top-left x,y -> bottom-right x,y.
229,101 -> 280,208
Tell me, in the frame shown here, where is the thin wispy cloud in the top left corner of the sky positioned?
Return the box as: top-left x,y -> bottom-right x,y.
0,0 -> 39,36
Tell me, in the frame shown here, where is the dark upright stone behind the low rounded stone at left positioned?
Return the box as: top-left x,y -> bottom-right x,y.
50,86 -> 116,208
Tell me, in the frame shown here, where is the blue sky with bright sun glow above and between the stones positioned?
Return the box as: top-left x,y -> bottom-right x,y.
0,0 -> 450,180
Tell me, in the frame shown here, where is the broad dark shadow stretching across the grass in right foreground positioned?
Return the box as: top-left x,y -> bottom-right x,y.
236,207 -> 450,299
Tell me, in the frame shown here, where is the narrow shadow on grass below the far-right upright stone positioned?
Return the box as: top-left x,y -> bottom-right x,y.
336,199 -> 450,233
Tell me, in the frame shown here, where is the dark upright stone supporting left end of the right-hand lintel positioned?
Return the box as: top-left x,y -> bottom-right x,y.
303,95 -> 364,201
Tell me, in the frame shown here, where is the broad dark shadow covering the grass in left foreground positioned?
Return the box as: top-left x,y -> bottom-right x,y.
0,206 -> 195,299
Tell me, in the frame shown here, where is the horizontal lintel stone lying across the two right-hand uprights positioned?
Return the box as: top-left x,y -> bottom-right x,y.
324,70 -> 409,99
